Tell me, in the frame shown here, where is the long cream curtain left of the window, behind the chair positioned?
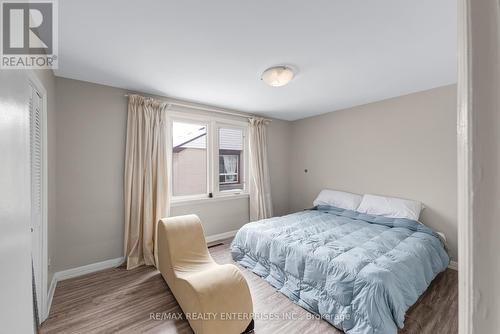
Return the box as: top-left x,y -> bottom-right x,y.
124,95 -> 170,269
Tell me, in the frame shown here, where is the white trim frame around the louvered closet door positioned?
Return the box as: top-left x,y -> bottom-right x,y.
28,70 -> 49,323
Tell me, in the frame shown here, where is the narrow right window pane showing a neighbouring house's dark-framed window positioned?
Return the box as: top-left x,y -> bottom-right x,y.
219,128 -> 244,191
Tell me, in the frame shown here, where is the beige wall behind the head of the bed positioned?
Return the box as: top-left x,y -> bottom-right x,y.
289,85 -> 457,259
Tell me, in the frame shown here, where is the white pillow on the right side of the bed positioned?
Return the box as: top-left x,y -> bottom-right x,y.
356,195 -> 422,220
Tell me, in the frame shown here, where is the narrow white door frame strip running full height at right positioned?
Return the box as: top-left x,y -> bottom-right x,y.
457,0 -> 474,334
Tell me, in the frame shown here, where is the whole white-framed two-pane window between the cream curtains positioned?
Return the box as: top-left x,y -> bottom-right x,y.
171,112 -> 247,202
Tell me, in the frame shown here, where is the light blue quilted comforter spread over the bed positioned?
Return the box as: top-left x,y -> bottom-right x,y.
231,207 -> 449,334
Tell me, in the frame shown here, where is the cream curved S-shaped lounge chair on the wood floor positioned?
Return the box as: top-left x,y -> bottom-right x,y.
158,215 -> 253,334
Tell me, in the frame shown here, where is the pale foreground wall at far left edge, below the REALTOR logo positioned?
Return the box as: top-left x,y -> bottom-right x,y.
0,70 -> 33,333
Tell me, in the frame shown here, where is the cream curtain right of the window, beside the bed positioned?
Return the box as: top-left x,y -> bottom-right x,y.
249,118 -> 273,221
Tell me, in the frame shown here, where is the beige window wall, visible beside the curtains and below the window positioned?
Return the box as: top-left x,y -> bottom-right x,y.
51,78 -> 290,271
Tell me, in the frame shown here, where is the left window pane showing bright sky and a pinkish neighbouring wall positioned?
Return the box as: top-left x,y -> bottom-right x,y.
172,122 -> 207,196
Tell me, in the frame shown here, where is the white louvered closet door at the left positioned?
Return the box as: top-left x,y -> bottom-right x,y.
29,86 -> 43,310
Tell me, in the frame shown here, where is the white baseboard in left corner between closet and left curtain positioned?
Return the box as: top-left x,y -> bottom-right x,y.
43,257 -> 125,320
